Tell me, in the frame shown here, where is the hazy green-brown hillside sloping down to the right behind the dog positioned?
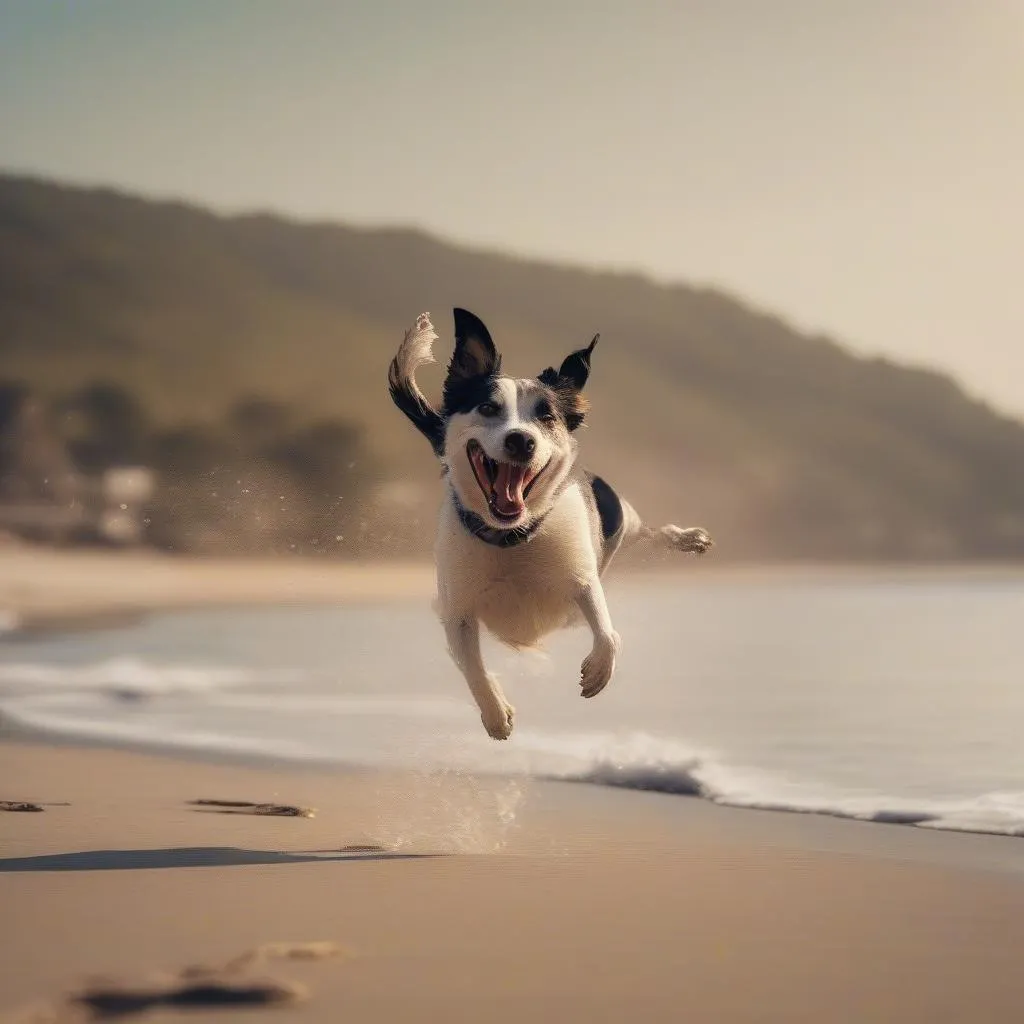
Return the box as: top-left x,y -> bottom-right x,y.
0,177 -> 1024,559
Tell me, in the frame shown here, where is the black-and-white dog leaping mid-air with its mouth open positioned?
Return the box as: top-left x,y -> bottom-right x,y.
388,308 -> 712,739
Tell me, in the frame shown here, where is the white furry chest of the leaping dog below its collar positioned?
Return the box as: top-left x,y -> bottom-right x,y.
437,487 -> 596,647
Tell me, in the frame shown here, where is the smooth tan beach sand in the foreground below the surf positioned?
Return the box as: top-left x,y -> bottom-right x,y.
0,740 -> 1024,1024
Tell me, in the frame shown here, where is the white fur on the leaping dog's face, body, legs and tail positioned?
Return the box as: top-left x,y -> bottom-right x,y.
392,313 -> 712,739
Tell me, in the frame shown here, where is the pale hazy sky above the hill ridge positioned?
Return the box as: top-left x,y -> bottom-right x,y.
0,0 -> 1024,414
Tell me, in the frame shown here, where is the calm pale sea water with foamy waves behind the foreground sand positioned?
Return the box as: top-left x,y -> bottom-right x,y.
0,574 -> 1024,836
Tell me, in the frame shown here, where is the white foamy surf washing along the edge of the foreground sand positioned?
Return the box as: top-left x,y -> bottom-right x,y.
6,656 -> 1024,836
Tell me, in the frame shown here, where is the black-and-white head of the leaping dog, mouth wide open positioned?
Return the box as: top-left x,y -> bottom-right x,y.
442,309 -> 597,529
